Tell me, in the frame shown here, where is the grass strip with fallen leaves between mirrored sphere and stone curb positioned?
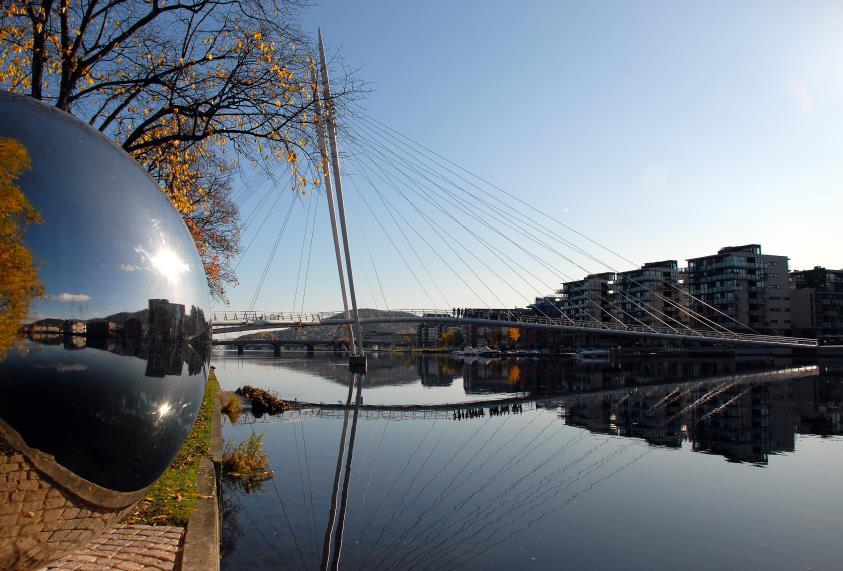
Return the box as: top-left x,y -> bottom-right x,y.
123,370 -> 220,526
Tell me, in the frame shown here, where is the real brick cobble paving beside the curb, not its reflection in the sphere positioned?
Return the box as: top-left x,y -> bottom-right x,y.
42,525 -> 184,571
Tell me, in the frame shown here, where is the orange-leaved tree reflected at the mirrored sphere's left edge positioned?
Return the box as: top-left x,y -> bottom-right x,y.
0,137 -> 44,357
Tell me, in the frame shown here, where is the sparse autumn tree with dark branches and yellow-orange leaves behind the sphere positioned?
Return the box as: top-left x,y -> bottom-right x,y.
0,0 -> 348,302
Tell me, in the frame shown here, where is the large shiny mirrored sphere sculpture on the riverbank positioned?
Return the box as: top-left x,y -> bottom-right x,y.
0,92 -> 210,569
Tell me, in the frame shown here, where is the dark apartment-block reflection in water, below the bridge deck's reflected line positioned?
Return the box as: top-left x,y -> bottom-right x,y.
560,362 -> 843,465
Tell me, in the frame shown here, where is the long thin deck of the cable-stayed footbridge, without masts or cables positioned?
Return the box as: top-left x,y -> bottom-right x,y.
211,309 -> 817,348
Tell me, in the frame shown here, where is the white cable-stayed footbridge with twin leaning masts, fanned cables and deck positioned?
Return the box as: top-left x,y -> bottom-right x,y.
226,38 -> 817,362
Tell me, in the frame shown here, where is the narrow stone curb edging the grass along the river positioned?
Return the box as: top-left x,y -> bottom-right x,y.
181,386 -> 222,571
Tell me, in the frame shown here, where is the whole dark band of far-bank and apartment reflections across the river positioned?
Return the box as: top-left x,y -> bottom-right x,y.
223,352 -> 843,465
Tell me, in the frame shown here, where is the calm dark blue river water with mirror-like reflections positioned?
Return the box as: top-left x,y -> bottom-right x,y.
212,352 -> 843,570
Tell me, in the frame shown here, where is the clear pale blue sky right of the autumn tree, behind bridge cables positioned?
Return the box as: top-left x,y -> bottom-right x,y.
217,0 -> 843,311
